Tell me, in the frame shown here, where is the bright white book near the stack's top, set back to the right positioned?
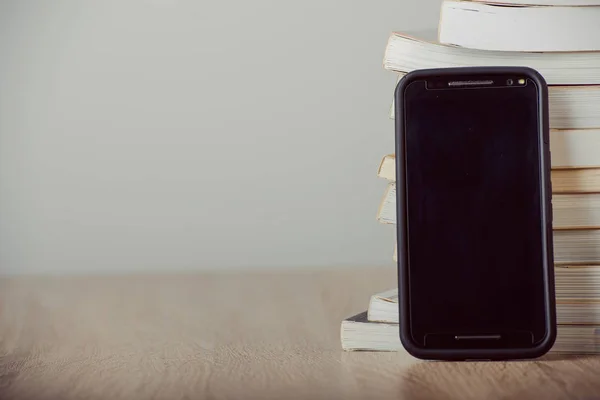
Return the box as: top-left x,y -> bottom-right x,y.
438,0 -> 600,52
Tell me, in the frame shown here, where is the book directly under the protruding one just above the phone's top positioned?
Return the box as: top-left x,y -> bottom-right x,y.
390,81 -> 600,131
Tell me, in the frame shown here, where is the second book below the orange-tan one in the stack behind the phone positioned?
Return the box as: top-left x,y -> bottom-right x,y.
392,229 -> 600,266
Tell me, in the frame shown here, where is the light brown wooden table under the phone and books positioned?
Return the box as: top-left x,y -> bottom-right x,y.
0,268 -> 600,400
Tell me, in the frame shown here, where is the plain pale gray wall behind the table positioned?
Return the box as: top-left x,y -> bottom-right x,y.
0,0 -> 440,273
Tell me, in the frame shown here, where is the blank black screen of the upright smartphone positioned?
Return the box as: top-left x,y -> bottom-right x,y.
404,80 -> 546,347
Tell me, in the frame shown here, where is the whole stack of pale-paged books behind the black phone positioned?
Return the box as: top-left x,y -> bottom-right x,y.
341,0 -> 600,354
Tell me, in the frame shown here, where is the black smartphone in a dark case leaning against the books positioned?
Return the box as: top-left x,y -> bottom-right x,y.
395,67 -> 556,360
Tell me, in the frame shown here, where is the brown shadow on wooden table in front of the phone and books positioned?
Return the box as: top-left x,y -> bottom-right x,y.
397,354 -> 600,400
